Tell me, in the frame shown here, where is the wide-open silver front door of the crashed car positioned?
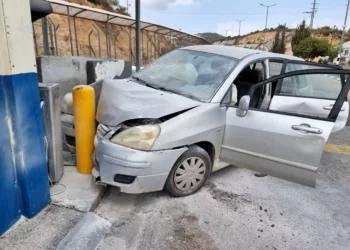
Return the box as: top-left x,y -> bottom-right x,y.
220,69 -> 350,187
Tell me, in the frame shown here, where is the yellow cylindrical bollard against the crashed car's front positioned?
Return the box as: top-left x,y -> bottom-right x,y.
73,85 -> 96,174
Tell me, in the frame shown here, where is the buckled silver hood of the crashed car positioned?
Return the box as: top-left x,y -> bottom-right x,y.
96,79 -> 201,126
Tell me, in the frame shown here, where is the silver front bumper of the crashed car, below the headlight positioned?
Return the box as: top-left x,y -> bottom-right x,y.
93,137 -> 188,194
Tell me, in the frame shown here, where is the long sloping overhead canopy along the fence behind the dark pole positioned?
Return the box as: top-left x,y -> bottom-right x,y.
47,0 -> 210,44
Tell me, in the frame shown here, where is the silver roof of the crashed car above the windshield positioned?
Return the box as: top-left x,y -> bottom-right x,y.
181,45 -> 302,60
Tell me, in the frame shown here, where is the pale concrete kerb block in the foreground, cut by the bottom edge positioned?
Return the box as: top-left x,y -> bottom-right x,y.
57,212 -> 112,250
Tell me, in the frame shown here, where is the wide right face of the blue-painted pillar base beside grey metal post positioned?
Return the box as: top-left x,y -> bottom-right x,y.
0,73 -> 50,234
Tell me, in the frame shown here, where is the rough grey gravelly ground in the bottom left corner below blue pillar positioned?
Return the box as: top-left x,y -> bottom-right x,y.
0,205 -> 83,250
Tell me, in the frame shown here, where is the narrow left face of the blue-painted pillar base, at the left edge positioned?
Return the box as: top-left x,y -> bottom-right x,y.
0,77 -> 21,235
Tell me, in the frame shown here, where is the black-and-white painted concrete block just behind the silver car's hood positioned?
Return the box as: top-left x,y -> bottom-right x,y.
86,60 -> 131,84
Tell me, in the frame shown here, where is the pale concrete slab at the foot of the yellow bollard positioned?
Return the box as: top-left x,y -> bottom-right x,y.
51,166 -> 107,212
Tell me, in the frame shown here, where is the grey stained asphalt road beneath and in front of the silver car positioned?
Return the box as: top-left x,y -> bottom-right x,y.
96,127 -> 350,250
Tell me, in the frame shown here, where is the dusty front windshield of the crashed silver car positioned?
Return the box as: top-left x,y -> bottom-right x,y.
134,49 -> 237,101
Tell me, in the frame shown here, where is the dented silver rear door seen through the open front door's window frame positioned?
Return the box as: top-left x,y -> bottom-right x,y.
270,60 -> 349,132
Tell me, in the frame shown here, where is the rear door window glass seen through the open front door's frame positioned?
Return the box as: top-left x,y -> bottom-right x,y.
278,64 -> 342,100
